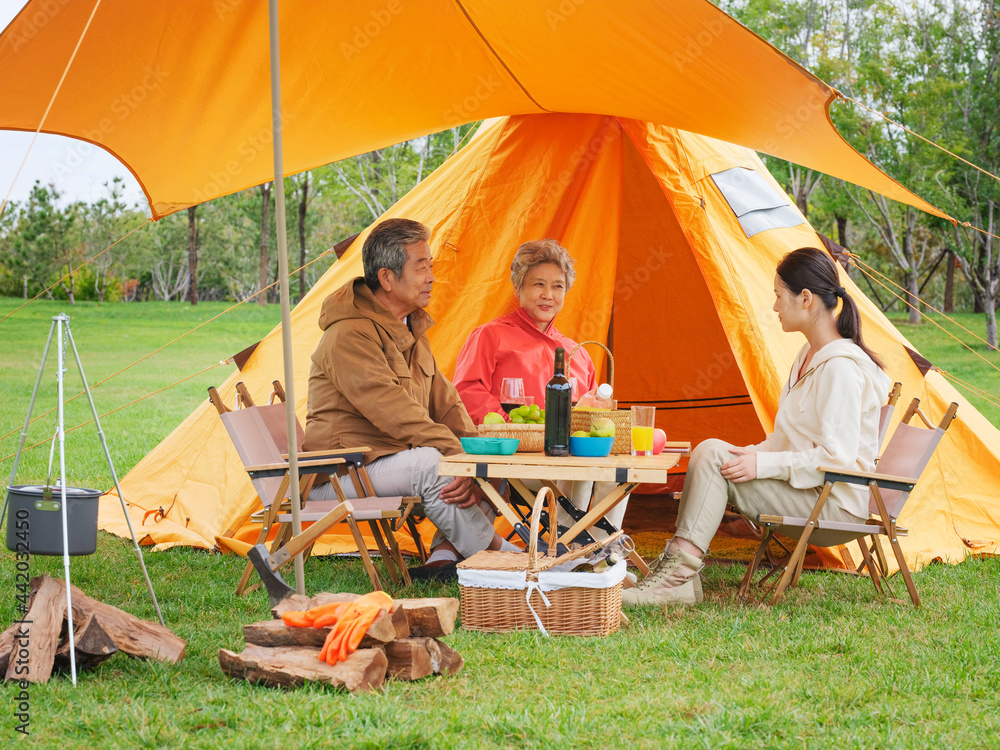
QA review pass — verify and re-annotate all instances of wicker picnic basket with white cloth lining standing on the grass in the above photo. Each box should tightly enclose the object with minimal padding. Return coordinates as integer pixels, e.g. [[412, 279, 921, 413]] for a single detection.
[[458, 487, 625, 635]]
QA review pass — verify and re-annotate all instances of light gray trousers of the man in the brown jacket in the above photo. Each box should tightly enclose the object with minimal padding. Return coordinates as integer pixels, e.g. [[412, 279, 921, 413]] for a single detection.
[[310, 448, 494, 557]]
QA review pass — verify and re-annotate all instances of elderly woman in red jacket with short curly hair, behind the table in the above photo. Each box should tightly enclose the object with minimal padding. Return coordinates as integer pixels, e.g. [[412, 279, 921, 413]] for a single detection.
[[454, 240, 628, 526]]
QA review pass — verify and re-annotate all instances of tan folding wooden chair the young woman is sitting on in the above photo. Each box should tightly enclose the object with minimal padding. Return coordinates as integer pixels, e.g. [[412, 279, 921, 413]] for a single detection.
[[739, 398, 958, 607]]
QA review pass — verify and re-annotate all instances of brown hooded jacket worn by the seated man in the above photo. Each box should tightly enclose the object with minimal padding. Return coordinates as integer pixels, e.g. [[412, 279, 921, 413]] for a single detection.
[[303, 278, 476, 461]]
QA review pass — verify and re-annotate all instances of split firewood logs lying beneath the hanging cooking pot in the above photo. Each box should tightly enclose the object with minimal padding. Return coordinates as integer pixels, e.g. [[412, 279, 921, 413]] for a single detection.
[[0, 575, 186, 683]]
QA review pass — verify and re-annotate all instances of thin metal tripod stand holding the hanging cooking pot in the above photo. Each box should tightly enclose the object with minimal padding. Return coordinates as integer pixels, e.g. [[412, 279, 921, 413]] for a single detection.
[[0, 313, 164, 685]]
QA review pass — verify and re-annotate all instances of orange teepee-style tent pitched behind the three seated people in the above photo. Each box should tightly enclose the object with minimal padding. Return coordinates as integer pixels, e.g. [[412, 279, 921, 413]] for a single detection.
[[101, 115, 1000, 567]]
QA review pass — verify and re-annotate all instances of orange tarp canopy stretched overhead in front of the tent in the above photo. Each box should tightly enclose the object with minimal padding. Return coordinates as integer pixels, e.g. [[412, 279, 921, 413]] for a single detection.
[[0, 0, 942, 218]]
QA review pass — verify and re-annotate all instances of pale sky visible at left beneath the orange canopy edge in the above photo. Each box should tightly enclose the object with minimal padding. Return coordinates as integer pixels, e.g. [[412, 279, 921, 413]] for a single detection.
[[0, 0, 148, 211]]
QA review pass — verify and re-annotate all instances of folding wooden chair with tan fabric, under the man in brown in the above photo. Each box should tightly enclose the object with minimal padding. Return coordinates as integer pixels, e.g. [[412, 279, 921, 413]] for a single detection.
[[208, 381, 419, 595]]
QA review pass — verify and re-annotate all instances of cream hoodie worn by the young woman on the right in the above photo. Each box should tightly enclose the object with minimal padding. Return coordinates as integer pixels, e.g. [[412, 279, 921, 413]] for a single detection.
[[755, 339, 892, 518]]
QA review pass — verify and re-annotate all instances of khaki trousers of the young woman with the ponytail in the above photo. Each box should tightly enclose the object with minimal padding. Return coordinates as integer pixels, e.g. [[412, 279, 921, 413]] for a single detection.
[[676, 438, 865, 552]]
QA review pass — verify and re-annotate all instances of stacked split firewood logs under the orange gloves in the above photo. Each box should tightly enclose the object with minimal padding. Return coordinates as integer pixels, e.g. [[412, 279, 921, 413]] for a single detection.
[[219, 593, 465, 692]]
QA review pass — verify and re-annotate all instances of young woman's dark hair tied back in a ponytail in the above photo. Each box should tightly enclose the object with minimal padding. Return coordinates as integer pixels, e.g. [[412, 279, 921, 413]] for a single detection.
[[778, 247, 885, 369]]
